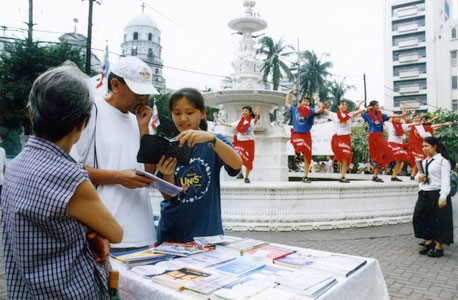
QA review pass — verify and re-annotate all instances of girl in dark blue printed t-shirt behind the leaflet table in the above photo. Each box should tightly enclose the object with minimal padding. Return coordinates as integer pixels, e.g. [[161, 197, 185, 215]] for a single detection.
[[157, 88, 242, 243]]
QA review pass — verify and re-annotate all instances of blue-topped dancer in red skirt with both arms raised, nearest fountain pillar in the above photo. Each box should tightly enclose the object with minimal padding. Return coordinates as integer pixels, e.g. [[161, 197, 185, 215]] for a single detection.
[[285, 89, 328, 183]]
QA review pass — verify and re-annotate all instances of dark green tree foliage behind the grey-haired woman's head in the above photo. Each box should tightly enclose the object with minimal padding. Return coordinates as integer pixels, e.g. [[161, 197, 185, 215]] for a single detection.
[[0, 40, 84, 154]]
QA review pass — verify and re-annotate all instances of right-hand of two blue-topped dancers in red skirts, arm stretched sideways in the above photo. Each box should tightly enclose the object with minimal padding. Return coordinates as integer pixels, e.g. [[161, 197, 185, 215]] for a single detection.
[[362, 100, 407, 182]]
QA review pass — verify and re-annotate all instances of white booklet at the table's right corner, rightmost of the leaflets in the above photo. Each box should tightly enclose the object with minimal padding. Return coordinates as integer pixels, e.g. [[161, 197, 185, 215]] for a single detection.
[[307, 254, 367, 277]]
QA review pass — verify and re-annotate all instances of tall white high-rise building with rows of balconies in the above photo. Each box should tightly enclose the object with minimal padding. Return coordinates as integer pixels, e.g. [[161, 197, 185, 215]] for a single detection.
[[384, 0, 458, 112]]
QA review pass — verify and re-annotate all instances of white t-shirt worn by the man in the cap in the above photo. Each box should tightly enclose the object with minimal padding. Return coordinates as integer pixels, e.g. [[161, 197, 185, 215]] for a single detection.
[[70, 99, 156, 248]]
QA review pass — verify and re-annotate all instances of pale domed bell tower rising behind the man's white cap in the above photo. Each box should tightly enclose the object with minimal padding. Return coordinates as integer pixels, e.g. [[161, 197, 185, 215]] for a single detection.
[[121, 13, 165, 92]]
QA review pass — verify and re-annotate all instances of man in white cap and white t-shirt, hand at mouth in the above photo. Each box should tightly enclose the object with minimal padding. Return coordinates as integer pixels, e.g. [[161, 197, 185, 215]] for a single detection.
[[70, 57, 157, 251]]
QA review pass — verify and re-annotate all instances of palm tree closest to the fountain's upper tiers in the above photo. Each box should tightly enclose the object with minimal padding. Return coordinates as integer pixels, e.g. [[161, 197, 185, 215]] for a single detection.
[[257, 36, 294, 91]]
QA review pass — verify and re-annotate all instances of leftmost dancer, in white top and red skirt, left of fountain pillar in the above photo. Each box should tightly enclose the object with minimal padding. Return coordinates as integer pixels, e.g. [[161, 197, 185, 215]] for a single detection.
[[219, 106, 261, 183]]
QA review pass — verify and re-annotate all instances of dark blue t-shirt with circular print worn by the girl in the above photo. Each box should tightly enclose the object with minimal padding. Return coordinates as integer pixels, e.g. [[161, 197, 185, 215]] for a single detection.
[[157, 134, 239, 243]]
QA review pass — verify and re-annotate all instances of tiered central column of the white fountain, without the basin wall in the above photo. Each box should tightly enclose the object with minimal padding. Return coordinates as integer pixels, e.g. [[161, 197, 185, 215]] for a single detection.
[[204, 0, 288, 181]]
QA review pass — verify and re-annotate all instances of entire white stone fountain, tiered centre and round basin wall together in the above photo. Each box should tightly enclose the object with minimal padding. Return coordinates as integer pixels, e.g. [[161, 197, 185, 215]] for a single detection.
[[151, 0, 432, 231]]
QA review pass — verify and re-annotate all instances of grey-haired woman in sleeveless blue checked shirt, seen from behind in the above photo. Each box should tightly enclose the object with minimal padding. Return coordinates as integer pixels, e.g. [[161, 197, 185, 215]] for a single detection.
[[1, 66, 123, 299]]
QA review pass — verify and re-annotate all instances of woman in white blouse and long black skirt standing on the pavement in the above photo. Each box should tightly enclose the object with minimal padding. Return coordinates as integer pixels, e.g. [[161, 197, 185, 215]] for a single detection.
[[413, 137, 455, 257]]
